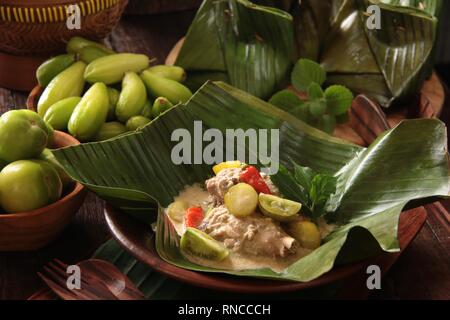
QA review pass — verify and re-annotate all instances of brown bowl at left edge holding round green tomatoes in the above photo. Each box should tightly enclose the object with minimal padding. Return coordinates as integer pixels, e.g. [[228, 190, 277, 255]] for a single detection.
[[0, 131, 86, 251]]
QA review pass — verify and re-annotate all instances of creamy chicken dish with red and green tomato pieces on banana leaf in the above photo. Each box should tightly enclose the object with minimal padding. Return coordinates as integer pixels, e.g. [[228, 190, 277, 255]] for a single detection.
[[165, 161, 333, 272]]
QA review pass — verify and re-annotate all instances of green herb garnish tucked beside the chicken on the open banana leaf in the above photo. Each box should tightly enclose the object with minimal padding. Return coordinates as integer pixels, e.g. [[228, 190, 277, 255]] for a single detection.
[[271, 162, 337, 219]]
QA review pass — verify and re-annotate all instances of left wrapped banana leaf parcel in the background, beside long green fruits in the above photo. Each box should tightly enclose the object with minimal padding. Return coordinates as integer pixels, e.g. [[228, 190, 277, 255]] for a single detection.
[[176, 0, 294, 98]]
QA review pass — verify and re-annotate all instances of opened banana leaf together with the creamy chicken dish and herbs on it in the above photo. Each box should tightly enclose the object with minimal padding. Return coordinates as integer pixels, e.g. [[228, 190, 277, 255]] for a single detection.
[[54, 81, 450, 281]]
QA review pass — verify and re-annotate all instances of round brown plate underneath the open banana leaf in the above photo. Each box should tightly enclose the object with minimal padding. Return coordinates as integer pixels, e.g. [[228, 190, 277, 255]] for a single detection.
[[105, 204, 426, 294]]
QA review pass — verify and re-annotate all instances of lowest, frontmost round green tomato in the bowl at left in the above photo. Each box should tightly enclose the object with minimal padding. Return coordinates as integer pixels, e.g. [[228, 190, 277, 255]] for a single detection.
[[0, 160, 62, 213]]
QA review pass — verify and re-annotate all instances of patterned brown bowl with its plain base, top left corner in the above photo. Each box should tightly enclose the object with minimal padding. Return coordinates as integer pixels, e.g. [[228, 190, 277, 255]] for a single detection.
[[0, 0, 128, 91]]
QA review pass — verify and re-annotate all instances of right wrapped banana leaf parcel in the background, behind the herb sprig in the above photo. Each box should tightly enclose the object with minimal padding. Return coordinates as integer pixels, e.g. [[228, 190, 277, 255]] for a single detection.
[[294, 0, 442, 107]]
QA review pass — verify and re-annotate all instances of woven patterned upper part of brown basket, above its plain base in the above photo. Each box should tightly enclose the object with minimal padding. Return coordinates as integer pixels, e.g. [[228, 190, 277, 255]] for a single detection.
[[0, 0, 128, 56]]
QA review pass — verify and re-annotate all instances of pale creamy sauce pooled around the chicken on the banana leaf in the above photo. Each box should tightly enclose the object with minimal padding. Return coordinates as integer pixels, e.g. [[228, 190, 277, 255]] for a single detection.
[[167, 184, 332, 272]]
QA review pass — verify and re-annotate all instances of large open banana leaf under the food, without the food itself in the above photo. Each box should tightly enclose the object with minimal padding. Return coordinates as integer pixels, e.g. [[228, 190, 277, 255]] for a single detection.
[[54, 82, 449, 281]]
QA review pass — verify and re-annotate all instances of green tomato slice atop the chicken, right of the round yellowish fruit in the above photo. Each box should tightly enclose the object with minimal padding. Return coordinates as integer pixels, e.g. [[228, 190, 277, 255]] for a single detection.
[[259, 193, 302, 222]]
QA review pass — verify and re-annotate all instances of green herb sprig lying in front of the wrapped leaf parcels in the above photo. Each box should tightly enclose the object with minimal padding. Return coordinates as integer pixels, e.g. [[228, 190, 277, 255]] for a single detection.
[[269, 59, 353, 134]]
